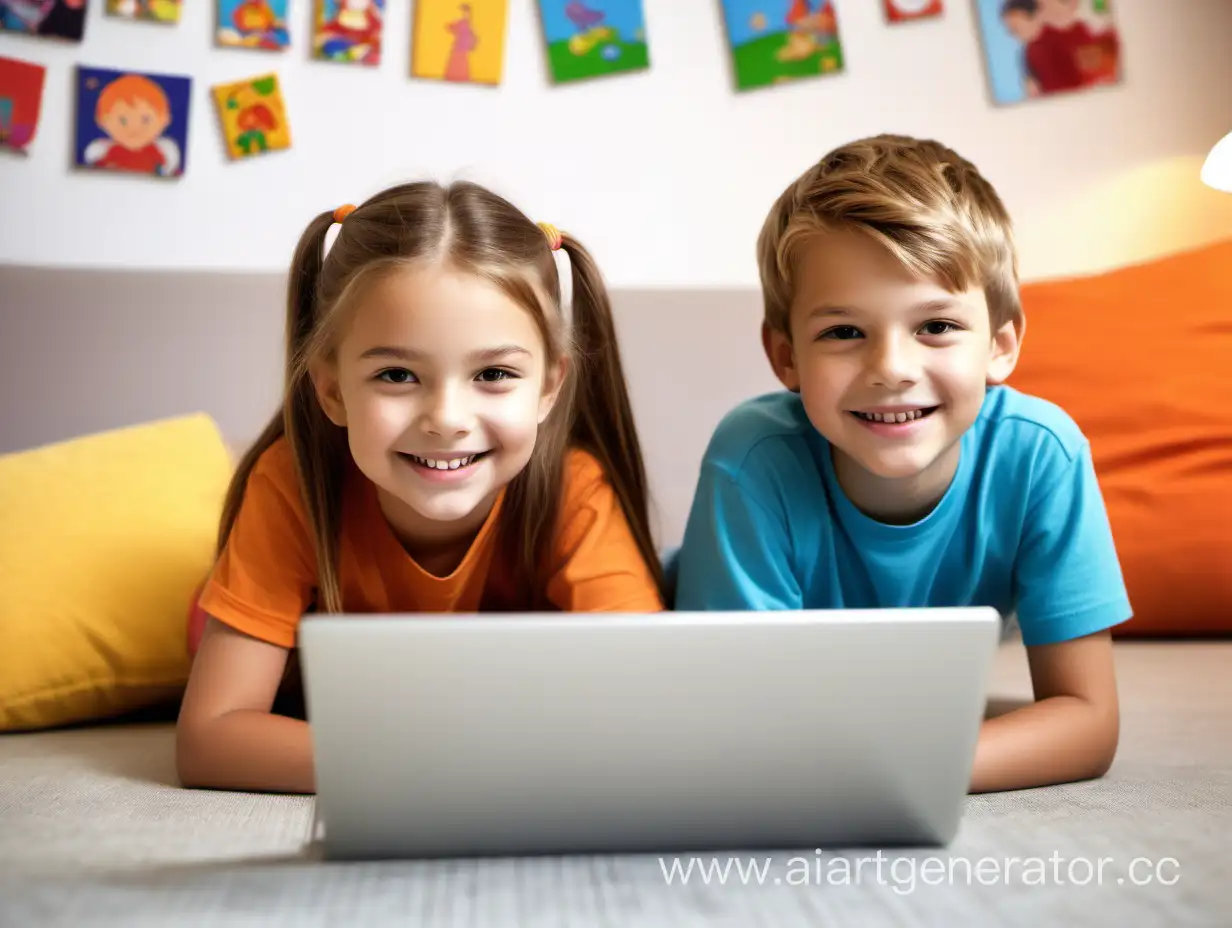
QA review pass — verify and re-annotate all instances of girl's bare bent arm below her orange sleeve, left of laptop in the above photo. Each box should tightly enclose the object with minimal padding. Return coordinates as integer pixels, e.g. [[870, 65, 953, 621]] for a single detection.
[[175, 617, 315, 792]]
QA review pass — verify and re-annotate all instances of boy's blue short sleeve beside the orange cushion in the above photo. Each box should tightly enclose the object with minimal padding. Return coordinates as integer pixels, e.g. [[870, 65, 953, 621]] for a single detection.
[[1015, 441, 1132, 646]]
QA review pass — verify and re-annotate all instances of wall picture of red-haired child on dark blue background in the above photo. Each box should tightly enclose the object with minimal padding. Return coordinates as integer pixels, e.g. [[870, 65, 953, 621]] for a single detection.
[[76, 67, 192, 177]]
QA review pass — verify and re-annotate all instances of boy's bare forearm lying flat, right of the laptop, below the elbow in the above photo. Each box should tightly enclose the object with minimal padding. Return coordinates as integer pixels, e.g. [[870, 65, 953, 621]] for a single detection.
[[971, 696, 1119, 792]]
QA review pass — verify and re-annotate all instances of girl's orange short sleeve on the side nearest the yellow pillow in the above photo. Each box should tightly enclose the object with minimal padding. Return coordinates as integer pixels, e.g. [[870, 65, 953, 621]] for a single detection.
[[200, 442, 317, 648]]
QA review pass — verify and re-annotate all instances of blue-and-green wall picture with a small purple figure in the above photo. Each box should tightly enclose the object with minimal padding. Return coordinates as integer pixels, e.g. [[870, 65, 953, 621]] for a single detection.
[[538, 0, 650, 84]]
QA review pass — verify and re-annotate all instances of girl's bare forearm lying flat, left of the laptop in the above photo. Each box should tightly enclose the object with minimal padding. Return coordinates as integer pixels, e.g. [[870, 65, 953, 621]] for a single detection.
[[176, 710, 317, 792]]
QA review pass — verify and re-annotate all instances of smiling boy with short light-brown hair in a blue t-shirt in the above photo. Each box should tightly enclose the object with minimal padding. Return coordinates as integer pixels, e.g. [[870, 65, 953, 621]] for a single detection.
[[675, 136, 1131, 792]]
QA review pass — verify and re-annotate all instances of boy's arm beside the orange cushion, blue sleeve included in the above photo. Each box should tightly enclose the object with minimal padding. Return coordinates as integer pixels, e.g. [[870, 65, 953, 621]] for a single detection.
[[971, 444, 1131, 792]]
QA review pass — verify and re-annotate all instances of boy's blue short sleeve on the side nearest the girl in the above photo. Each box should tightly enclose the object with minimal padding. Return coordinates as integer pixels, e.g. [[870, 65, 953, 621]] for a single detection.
[[675, 462, 803, 611]]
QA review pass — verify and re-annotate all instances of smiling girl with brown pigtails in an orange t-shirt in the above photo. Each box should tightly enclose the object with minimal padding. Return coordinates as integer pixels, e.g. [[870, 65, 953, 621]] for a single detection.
[[176, 184, 663, 792]]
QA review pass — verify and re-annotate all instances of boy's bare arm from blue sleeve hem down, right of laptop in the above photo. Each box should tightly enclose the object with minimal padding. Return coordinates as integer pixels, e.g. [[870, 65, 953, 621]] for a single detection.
[[971, 631, 1120, 792]]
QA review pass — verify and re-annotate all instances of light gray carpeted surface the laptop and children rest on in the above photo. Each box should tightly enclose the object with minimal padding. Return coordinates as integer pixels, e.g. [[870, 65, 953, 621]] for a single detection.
[[0, 642, 1232, 928]]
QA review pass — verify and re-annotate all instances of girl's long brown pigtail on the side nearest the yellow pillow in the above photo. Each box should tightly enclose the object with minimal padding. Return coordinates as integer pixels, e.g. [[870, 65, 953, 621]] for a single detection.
[[217, 212, 346, 613]]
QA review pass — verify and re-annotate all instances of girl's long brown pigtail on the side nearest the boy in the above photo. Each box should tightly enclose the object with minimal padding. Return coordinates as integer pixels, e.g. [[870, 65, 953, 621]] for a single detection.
[[561, 234, 663, 592]]
